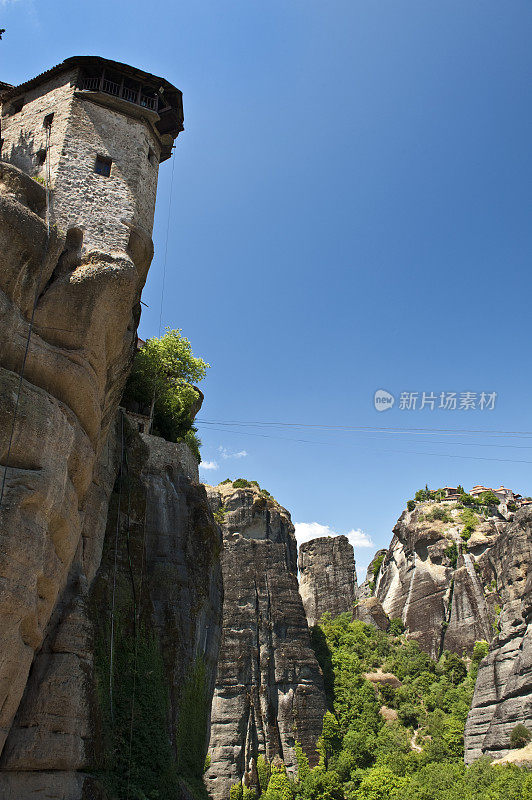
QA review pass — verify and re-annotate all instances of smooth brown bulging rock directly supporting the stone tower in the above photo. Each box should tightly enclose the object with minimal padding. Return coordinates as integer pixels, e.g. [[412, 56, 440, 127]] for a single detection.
[[0, 162, 151, 764]]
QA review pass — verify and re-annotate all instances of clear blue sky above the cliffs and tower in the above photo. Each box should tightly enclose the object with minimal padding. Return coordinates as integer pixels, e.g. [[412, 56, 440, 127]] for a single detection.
[[4, 0, 532, 567]]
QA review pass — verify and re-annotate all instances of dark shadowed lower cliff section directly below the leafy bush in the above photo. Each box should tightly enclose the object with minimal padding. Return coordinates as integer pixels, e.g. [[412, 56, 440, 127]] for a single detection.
[[0, 417, 222, 800]]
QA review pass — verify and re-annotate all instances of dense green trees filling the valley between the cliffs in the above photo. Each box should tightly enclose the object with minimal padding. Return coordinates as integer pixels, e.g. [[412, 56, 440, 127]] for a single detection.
[[234, 614, 532, 800]]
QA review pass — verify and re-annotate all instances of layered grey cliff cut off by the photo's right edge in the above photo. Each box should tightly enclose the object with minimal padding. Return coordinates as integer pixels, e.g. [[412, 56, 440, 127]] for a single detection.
[[465, 509, 532, 762]]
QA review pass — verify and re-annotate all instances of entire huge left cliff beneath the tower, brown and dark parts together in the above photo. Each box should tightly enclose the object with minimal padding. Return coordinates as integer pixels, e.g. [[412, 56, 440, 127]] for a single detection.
[[0, 162, 222, 800]]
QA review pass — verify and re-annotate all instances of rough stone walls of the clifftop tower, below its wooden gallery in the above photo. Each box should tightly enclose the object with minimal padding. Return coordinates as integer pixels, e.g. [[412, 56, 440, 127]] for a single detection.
[[2, 69, 160, 252]]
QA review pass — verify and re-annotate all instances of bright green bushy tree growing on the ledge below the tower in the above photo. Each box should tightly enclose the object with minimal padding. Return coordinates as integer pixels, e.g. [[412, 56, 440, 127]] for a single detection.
[[123, 329, 209, 458]]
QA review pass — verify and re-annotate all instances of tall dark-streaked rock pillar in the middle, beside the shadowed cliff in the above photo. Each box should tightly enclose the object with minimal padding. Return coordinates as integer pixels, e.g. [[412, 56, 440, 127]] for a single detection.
[[206, 483, 325, 800]]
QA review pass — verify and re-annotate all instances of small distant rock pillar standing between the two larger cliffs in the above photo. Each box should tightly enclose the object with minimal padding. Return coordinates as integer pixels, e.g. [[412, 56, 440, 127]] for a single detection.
[[299, 536, 357, 626]]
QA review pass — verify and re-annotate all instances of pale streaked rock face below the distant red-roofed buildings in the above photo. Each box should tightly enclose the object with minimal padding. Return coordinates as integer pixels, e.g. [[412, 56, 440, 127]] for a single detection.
[[375, 502, 494, 658]]
